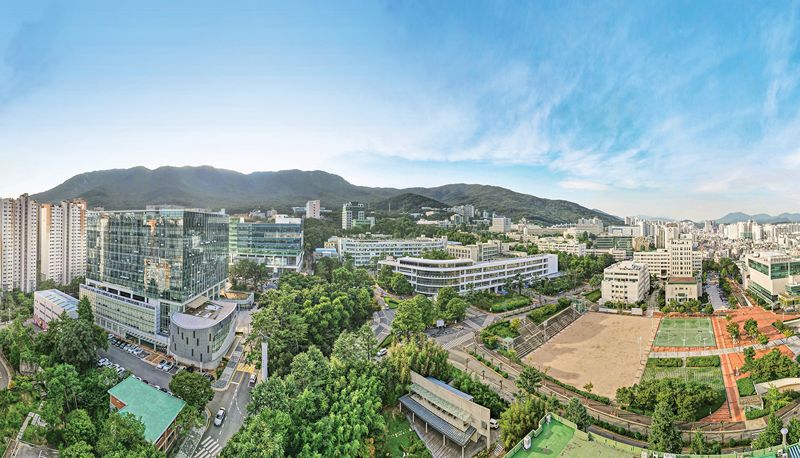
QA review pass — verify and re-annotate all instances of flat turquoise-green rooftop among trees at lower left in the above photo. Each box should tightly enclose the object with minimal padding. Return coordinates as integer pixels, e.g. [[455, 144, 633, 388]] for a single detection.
[[108, 376, 186, 443]]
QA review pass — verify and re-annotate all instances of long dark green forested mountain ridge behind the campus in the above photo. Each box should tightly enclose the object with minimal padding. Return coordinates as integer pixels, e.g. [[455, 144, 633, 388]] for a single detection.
[[32, 165, 621, 224]]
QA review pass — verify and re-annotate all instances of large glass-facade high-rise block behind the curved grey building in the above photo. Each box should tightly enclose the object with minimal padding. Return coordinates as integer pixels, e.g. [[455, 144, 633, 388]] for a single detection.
[[81, 208, 228, 347]]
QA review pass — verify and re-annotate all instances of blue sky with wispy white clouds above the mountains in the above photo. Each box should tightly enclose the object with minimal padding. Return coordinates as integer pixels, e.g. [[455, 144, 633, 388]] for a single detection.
[[0, 0, 800, 219]]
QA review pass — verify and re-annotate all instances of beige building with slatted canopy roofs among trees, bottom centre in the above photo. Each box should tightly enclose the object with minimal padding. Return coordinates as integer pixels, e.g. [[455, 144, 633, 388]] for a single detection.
[[400, 371, 491, 458]]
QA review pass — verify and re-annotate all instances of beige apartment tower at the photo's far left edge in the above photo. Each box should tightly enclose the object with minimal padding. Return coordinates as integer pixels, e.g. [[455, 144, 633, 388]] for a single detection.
[[0, 194, 39, 293]]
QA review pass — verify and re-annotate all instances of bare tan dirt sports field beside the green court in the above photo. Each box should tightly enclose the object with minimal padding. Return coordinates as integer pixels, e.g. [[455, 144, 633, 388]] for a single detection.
[[524, 312, 658, 398]]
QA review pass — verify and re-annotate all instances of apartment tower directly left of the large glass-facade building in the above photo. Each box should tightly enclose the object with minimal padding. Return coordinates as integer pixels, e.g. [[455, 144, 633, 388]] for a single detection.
[[39, 200, 87, 285]]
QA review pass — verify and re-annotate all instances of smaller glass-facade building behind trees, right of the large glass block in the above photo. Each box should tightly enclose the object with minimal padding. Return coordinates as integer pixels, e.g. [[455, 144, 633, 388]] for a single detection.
[[228, 218, 303, 274]]
